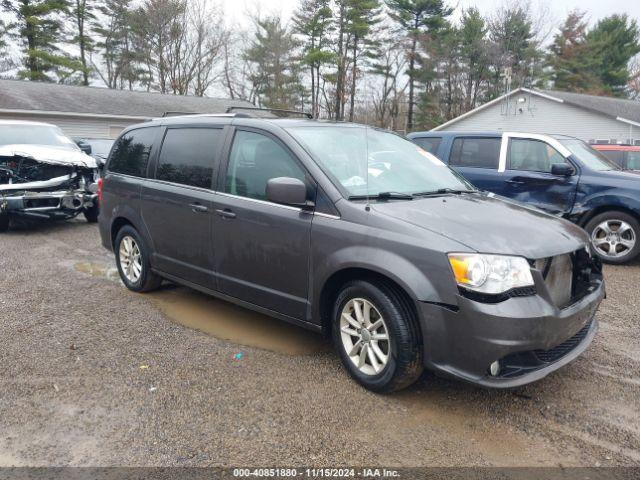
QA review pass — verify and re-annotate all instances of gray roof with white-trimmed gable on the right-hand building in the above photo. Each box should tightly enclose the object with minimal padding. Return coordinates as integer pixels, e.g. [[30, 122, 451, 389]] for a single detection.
[[433, 88, 640, 130]]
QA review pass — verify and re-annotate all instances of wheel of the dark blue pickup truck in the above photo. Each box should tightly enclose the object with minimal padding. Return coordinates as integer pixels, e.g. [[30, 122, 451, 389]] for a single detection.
[[585, 211, 640, 264]]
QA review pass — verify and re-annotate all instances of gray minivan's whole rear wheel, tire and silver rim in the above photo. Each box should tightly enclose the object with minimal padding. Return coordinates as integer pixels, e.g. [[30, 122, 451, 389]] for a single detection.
[[115, 225, 162, 293]]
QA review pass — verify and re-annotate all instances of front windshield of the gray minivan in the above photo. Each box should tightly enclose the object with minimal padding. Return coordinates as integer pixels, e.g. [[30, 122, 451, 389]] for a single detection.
[[287, 125, 473, 199]]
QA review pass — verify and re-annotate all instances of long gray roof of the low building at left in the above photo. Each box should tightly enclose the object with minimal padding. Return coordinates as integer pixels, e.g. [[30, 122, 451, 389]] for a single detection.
[[0, 80, 253, 119]]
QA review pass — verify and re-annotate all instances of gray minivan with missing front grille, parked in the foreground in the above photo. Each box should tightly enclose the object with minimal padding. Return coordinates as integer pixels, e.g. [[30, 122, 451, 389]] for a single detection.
[[99, 113, 604, 392]]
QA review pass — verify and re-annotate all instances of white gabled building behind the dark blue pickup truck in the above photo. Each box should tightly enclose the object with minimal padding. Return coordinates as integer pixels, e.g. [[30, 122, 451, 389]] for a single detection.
[[434, 88, 640, 145]]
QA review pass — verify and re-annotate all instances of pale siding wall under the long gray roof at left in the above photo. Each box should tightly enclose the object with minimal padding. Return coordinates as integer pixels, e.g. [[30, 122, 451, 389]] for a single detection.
[[0, 113, 144, 139]]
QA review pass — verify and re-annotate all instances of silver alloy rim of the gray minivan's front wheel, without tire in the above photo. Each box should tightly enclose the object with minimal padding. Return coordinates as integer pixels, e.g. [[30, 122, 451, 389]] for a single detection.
[[340, 298, 391, 375]]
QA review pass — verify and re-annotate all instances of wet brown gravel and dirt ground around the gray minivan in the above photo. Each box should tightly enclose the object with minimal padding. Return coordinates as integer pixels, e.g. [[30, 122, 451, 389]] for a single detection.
[[0, 220, 640, 466]]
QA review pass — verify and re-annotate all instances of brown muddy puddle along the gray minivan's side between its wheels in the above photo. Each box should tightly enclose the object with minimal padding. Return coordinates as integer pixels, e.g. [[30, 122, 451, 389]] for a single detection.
[[148, 286, 330, 355]]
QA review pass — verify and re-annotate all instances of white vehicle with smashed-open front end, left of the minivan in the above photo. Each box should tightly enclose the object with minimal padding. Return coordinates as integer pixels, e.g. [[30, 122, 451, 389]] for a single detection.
[[0, 120, 99, 232]]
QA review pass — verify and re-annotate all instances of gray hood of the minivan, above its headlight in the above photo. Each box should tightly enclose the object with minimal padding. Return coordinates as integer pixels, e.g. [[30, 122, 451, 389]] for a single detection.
[[372, 194, 589, 259]]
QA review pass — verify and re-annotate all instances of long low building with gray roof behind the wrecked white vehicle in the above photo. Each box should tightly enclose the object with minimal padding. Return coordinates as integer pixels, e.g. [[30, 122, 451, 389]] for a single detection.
[[0, 80, 253, 138]]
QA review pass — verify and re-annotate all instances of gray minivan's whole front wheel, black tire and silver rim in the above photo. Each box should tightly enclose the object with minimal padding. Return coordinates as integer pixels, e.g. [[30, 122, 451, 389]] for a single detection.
[[332, 280, 424, 393]]
